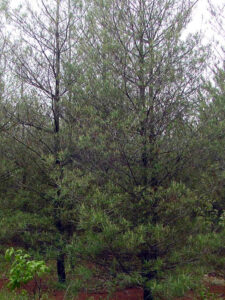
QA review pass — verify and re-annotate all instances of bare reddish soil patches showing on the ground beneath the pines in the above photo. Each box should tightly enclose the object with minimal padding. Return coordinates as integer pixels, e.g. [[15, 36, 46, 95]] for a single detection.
[[0, 279, 225, 300]]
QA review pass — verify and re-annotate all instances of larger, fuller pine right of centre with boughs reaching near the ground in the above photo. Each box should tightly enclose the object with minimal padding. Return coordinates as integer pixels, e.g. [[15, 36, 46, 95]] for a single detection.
[[68, 0, 216, 299]]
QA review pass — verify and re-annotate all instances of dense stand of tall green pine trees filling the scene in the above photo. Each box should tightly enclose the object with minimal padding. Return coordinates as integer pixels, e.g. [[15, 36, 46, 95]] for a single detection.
[[0, 0, 225, 299]]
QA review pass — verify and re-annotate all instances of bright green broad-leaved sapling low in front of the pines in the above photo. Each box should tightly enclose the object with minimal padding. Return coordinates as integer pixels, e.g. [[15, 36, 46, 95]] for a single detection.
[[5, 248, 49, 290]]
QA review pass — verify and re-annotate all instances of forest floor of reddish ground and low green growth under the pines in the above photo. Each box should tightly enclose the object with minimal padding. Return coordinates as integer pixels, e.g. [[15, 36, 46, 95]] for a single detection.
[[0, 274, 225, 300]]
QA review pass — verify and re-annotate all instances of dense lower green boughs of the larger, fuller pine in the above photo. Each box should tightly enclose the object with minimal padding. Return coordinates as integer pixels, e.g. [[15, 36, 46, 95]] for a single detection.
[[71, 182, 220, 299]]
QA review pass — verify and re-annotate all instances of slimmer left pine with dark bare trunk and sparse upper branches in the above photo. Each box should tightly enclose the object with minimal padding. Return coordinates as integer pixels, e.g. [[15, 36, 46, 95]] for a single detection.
[[1, 0, 82, 282]]
